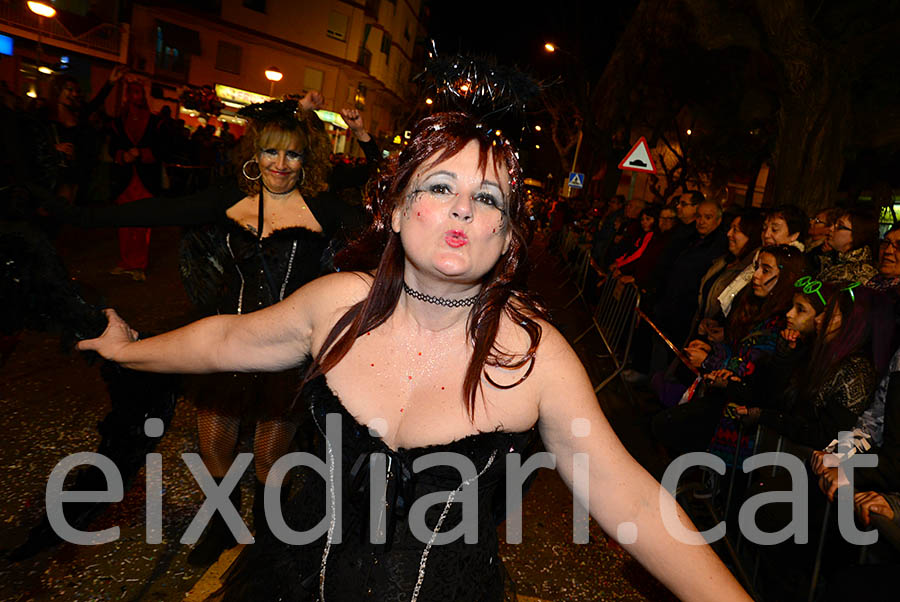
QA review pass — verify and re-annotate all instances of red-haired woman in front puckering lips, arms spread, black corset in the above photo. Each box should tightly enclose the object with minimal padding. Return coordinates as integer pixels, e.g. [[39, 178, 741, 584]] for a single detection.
[[79, 113, 749, 602]]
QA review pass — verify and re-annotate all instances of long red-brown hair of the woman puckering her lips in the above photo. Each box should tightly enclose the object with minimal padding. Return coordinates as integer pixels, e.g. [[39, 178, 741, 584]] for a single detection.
[[304, 113, 547, 419]]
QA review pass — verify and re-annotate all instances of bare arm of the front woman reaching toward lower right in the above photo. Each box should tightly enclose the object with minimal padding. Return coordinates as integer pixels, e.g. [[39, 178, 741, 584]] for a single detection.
[[536, 327, 750, 602]]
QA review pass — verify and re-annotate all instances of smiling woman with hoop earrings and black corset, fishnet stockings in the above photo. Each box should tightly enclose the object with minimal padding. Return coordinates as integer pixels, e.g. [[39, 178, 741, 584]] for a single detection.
[[46, 95, 377, 565]]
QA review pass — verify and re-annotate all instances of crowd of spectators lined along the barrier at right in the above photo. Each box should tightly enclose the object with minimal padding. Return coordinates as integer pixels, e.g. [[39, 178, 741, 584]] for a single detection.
[[549, 192, 900, 600]]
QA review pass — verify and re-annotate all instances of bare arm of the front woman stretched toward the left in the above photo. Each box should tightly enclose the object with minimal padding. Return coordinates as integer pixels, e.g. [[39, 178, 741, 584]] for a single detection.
[[78, 273, 358, 374]]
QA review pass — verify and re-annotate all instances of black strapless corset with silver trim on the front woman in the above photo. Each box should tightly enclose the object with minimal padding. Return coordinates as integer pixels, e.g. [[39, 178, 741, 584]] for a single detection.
[[216, 377, 534, 602]]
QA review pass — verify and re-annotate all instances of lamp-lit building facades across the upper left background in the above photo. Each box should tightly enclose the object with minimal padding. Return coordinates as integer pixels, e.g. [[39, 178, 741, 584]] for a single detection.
[[0, 0, 427, 152]]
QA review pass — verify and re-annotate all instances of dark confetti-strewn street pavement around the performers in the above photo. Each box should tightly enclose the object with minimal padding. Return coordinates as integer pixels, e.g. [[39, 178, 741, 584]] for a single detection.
[[0, 223, 674, 602]]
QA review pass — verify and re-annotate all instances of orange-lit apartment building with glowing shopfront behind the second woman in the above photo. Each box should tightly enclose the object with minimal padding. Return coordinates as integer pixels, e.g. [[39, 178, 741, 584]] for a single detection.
[[129, 0, 425, 152]]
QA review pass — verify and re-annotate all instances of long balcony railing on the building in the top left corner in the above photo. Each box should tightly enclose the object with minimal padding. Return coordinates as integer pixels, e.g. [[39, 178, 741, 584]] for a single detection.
[[0, 2, 128, 62]]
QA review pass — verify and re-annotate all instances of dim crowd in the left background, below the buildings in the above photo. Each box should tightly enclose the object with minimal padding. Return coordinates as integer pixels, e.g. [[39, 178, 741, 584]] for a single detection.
[[0, 66, 368, 280]]
